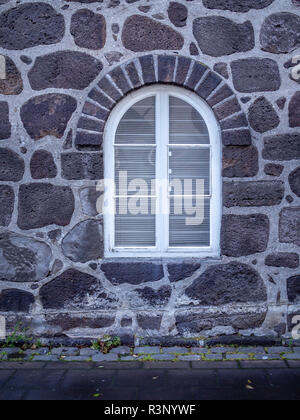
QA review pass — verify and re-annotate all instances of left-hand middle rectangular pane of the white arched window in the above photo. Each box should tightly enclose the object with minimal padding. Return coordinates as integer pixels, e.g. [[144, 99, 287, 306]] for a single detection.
[[115, 146, 156, 195]]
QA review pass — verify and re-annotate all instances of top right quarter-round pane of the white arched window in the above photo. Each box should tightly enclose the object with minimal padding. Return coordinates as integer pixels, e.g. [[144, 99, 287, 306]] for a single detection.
[[170, 96, 210, 144]]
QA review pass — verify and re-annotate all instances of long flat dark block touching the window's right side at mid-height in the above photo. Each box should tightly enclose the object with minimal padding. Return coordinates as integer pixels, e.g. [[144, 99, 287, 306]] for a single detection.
[[223, 181, 284, 207]]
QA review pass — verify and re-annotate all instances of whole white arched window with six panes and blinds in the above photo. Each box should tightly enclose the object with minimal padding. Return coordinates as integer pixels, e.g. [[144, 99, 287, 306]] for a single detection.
[[104, 85, 221, 258]]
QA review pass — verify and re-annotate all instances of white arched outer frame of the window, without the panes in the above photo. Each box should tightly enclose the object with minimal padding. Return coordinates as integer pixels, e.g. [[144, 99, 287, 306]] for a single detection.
[[103, 84, 222, 258]]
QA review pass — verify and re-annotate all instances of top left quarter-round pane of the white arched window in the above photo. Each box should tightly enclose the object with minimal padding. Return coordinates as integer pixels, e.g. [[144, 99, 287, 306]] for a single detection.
[[115, 96, 156, 144]]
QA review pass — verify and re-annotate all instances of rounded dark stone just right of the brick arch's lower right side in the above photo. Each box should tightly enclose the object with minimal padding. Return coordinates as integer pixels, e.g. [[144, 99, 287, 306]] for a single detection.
[[248, 96, 280, 133]]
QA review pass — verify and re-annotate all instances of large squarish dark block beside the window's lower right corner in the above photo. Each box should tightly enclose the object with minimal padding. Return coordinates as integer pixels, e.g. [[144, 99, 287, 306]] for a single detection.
[[221, 214, 270, 257]]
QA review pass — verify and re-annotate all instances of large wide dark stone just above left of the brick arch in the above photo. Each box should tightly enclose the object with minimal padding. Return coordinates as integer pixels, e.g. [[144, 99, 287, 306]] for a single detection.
[[28, 51, 103, 90]]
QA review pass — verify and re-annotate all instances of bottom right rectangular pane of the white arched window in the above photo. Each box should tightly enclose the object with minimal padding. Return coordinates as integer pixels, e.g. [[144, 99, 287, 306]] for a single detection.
[[169, 197, 210, 248]]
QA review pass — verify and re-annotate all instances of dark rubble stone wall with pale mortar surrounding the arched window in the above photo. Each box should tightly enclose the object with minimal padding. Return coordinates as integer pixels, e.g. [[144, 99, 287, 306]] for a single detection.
[[0, 0, 300, 337]]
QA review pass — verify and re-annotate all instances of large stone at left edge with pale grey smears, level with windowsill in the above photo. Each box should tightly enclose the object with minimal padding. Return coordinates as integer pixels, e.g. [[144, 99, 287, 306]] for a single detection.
[[0, 232, 52, 283]]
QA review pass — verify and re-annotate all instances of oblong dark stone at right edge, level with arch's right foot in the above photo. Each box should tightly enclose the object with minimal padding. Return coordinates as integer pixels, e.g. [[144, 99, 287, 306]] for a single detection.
[[262, 133, 300, 161]]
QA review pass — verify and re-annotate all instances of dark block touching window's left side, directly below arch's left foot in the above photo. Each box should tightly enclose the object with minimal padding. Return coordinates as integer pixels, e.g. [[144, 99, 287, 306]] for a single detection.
[[61, 152, 103, 180]]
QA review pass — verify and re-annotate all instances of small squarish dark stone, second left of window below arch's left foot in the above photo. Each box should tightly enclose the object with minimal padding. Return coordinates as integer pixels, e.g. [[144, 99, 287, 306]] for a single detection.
[[30, 150, 57, 179]]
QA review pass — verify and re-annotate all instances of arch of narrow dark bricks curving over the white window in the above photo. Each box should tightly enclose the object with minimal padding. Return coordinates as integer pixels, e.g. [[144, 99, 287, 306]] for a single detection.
[[75, 54, 252, 150]]
